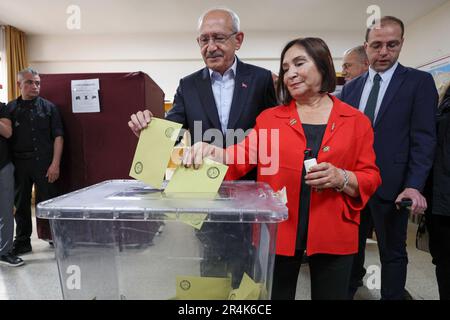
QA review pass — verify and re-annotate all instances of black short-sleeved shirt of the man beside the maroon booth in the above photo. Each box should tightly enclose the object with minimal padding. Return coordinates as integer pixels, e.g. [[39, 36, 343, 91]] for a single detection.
[[7, 97, 64, 164]]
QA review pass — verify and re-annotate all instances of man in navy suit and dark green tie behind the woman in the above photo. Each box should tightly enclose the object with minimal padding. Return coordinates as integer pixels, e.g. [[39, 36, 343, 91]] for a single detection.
[[341, 17, 438, 299]]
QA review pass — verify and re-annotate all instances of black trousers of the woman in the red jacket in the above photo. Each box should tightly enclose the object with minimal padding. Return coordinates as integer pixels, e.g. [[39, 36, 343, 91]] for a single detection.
[[272, 251, 353, 300]]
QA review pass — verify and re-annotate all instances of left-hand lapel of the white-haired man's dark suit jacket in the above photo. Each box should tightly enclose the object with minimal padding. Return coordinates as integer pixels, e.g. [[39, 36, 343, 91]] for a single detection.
[[195, 68, 222, 131]]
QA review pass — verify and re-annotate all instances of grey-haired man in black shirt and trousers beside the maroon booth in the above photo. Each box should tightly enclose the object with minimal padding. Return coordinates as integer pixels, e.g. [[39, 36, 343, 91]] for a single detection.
[[7, 68, 63, 255]]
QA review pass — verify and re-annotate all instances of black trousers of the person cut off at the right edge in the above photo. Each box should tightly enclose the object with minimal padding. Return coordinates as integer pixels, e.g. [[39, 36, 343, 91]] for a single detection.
[[426, 214, 450, 300]]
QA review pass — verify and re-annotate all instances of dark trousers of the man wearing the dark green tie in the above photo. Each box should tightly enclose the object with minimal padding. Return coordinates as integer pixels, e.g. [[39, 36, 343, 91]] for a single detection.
[[349, 195, 408, 300]]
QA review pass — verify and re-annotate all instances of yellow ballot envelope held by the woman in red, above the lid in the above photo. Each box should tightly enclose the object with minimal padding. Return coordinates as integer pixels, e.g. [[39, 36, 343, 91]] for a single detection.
[[164, 158, 228, 196]]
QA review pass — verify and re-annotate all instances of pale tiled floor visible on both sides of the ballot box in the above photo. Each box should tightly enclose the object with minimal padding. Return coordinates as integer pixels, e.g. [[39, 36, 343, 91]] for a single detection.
[[0, 219, 438, 300]]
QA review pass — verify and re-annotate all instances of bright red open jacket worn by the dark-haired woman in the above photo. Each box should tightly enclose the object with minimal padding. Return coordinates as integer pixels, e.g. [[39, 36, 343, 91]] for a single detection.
[[226, 96, 381, 256]]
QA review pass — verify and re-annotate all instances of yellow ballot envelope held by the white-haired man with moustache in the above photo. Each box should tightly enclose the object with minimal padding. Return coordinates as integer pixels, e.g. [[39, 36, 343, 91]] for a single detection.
[[130, 118, 182, 188]]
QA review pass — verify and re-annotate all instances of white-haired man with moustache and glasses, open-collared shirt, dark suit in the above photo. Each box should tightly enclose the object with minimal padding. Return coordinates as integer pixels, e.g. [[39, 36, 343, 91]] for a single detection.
[[128, 9, 277, 146]]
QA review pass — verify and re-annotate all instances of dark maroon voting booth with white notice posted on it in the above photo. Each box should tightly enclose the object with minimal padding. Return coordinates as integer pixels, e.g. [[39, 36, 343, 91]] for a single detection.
[[36, 72, 164, 244]]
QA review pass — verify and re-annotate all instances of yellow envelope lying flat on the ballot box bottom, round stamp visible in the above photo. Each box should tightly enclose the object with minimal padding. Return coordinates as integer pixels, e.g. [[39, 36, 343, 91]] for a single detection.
[[176, 276, 232, 300]]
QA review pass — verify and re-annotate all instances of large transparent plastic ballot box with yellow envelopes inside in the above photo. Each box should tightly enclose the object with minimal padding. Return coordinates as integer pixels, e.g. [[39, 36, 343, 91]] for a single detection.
[[37, 180, 288, 300]]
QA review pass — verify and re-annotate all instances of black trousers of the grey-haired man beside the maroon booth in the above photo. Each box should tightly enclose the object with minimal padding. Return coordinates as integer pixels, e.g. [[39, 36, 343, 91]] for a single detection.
[[14, 159, 56, 243]]
